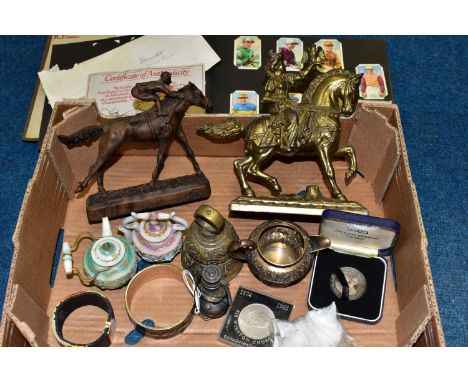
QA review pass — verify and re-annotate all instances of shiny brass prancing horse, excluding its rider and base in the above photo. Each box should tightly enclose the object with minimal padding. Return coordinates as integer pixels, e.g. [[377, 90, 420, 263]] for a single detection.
[[197, 69, 362, 202]]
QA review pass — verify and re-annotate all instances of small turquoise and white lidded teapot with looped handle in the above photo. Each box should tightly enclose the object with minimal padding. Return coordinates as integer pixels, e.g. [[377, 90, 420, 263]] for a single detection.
[[62, 217, 137, 289]]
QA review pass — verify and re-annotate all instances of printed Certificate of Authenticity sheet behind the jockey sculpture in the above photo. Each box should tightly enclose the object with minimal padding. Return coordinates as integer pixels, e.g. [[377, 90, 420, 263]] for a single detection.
[[86, 65, 205, 117]]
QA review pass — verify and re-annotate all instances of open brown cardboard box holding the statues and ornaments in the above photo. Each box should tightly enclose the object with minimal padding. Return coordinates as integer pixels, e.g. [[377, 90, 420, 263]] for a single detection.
[[0, 100, 444, 346]]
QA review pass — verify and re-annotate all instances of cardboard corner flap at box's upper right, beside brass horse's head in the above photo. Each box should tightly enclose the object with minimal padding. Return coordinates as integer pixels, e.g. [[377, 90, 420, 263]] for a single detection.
[[349, 103, 401, 203]]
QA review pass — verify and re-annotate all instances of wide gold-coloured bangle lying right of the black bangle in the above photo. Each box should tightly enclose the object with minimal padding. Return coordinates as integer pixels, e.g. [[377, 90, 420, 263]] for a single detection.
[[125, 264, 195, 338]]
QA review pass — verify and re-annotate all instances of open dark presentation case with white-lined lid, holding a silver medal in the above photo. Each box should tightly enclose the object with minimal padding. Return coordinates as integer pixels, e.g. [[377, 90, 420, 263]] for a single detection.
[[308, 210, 400, 324]]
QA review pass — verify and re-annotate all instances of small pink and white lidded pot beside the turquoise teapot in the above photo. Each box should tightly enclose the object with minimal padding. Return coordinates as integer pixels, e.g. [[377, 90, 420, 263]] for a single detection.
[[119, 212, 188, 263]]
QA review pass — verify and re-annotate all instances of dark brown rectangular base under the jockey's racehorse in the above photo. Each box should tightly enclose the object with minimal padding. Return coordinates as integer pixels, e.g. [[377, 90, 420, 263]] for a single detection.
[[86, 174, 211, 223]]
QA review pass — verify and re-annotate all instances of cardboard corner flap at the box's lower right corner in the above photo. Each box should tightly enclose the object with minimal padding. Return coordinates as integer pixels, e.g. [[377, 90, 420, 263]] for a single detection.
[[396, 285, 432, 346]]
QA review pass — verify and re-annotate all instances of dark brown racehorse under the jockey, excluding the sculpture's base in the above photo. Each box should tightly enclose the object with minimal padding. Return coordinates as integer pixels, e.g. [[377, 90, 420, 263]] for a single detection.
[[58, 82, 211, 193]]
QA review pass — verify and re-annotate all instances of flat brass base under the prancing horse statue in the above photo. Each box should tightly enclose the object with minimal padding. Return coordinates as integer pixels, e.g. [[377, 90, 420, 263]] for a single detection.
[[229, 185, 369, 215]]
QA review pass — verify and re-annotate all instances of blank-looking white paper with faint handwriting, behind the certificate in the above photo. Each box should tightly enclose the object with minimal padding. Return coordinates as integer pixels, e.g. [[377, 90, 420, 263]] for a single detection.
[[39, 36, 220, 107]]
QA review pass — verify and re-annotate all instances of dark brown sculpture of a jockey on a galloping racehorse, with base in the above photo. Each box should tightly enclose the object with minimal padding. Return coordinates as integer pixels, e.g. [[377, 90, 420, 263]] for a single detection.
[[58, 81, 211, 222]]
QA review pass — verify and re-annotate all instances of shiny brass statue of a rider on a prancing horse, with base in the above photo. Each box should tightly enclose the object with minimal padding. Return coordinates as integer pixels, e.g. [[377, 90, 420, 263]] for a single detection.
[[197, 46, 365, 215]]
